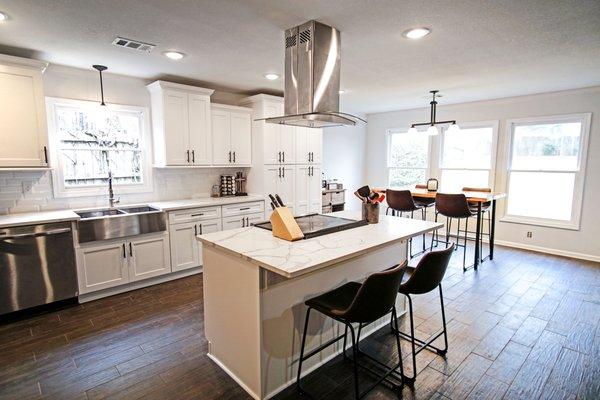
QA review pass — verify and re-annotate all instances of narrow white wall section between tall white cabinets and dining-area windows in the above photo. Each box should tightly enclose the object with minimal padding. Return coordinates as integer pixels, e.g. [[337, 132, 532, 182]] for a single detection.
[[323, 123, 367, 210]]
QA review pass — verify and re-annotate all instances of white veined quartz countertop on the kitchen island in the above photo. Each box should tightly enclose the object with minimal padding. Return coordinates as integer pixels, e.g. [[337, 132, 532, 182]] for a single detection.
[[198, 211, 443, 278]]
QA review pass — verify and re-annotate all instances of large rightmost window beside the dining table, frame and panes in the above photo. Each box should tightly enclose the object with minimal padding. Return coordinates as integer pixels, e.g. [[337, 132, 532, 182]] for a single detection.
[[504, 114, 590, 229]]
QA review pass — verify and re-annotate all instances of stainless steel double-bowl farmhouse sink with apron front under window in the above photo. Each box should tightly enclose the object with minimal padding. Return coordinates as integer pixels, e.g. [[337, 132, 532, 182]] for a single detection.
[[77, 206, 167, 243]]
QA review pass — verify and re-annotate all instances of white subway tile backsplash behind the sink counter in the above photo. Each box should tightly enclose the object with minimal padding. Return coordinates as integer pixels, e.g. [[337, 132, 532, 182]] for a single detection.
[[0, 168, 248, 214]]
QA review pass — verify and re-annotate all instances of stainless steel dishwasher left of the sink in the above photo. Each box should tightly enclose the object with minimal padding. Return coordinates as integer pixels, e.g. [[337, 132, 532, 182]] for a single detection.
[[0, 222, 78, 314]]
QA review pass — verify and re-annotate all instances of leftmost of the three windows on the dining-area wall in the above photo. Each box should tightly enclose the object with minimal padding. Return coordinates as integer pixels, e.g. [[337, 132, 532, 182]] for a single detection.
[[388, 130, 429, 187]]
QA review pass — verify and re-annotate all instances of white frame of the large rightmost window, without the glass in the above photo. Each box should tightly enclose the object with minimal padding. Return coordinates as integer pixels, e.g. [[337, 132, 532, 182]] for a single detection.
[[500, 113, 592, 230]]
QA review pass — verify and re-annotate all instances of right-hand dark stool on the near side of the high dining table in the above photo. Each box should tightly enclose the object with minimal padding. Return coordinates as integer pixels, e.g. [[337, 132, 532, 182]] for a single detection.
[[431, 193, 479, 271]]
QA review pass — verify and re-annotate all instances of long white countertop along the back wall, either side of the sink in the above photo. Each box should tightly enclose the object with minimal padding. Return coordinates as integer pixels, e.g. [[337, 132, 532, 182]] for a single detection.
[[0, 195, 264, 228]]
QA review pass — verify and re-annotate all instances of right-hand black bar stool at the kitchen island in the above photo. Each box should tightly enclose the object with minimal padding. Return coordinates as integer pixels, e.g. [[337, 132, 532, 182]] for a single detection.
[[391, 244, 454, 385]]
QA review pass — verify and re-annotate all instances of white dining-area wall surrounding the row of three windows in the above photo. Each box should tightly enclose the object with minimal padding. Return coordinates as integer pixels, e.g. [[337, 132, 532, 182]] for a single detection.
[[366, 87, 600, 261]]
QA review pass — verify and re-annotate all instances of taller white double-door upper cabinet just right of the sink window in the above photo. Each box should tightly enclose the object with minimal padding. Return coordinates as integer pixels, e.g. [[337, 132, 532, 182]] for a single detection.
[[147, 81, 213, 166]]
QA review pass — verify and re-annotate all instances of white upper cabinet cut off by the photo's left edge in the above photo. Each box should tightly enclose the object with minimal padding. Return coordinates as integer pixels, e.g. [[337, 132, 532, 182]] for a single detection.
[[0, 55, 48, 168]]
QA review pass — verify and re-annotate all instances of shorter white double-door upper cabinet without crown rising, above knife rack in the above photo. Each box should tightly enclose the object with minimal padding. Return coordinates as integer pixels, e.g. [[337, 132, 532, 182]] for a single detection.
[[211, 104, 252, 167]]
